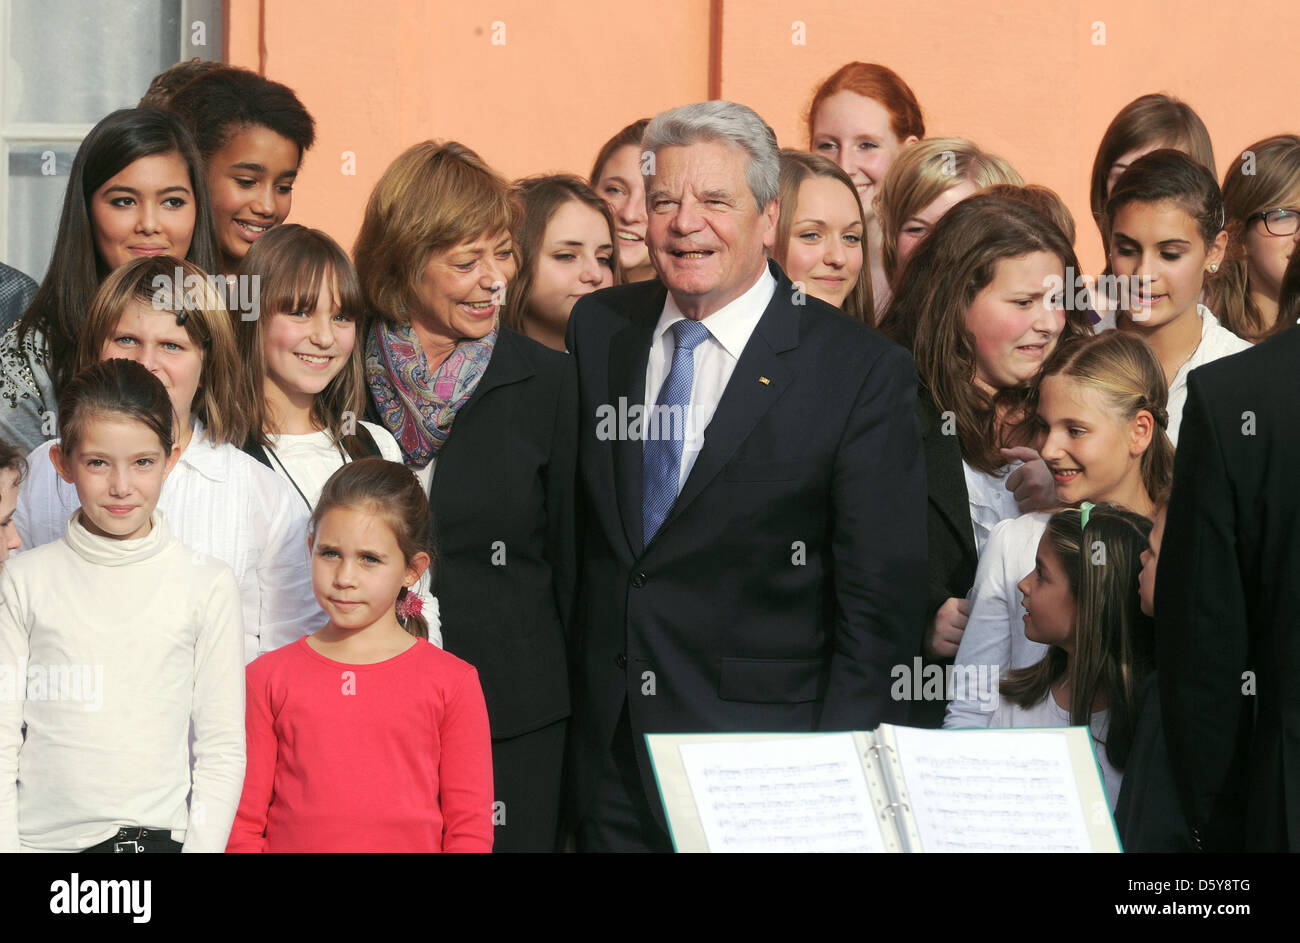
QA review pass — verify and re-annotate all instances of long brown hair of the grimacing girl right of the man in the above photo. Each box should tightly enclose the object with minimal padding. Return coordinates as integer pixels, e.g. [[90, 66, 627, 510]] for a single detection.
[[880, 193, 1092, 473]]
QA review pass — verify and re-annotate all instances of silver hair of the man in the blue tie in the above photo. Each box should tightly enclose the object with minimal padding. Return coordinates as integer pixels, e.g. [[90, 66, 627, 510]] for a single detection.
[[641, 100, 781, 212]]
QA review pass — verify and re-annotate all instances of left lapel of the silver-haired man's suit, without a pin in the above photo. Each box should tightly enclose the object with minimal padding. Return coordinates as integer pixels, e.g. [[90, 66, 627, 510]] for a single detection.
[[610, 286, 667, 557]]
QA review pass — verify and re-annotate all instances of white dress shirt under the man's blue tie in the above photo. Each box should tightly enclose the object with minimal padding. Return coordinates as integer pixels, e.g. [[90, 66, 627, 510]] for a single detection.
[[645, 265, 776, 492]]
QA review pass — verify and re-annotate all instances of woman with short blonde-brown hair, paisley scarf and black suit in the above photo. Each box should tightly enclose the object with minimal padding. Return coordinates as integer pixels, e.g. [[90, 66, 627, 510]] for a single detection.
[[354, 140, 579, 852]]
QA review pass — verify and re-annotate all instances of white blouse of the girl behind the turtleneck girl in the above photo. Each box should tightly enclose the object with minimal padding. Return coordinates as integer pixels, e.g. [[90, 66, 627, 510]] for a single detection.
[[13, 421, 328, 661]]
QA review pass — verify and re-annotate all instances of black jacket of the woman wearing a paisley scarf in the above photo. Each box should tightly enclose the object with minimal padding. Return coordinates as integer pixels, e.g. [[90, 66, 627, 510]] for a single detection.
[[371, 328, 577, 739]]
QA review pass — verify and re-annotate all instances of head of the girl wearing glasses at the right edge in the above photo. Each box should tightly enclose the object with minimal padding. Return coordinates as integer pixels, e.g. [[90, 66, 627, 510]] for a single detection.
[[1209, 134, 1300, 341]]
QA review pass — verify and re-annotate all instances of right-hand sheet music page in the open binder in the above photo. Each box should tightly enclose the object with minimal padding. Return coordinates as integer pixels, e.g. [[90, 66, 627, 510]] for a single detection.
[[894, 727, 1092, 852]]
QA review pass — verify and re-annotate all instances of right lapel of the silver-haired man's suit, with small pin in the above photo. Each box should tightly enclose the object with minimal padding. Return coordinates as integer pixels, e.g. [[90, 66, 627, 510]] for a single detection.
[[659, 263, 800, 533]]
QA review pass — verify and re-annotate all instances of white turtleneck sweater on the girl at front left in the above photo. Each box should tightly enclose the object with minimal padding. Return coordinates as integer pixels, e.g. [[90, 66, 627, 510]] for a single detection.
[[0, 510, 244, 852]]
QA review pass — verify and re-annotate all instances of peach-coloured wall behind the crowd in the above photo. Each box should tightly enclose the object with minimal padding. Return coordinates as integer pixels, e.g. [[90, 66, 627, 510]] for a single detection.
[[228, 0, 1300, 269]]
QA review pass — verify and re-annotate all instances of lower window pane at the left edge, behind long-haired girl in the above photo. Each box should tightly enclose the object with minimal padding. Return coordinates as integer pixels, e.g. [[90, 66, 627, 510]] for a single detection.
[[5, 144, 77, 281]]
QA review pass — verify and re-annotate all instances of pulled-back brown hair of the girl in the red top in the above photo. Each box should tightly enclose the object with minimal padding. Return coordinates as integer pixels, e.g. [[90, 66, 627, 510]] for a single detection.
[[310, 455, 434, 639]]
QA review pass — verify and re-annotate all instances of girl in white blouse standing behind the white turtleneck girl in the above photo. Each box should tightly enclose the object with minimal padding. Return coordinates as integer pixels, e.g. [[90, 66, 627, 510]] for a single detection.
[[17, 255, 324, 661]]
